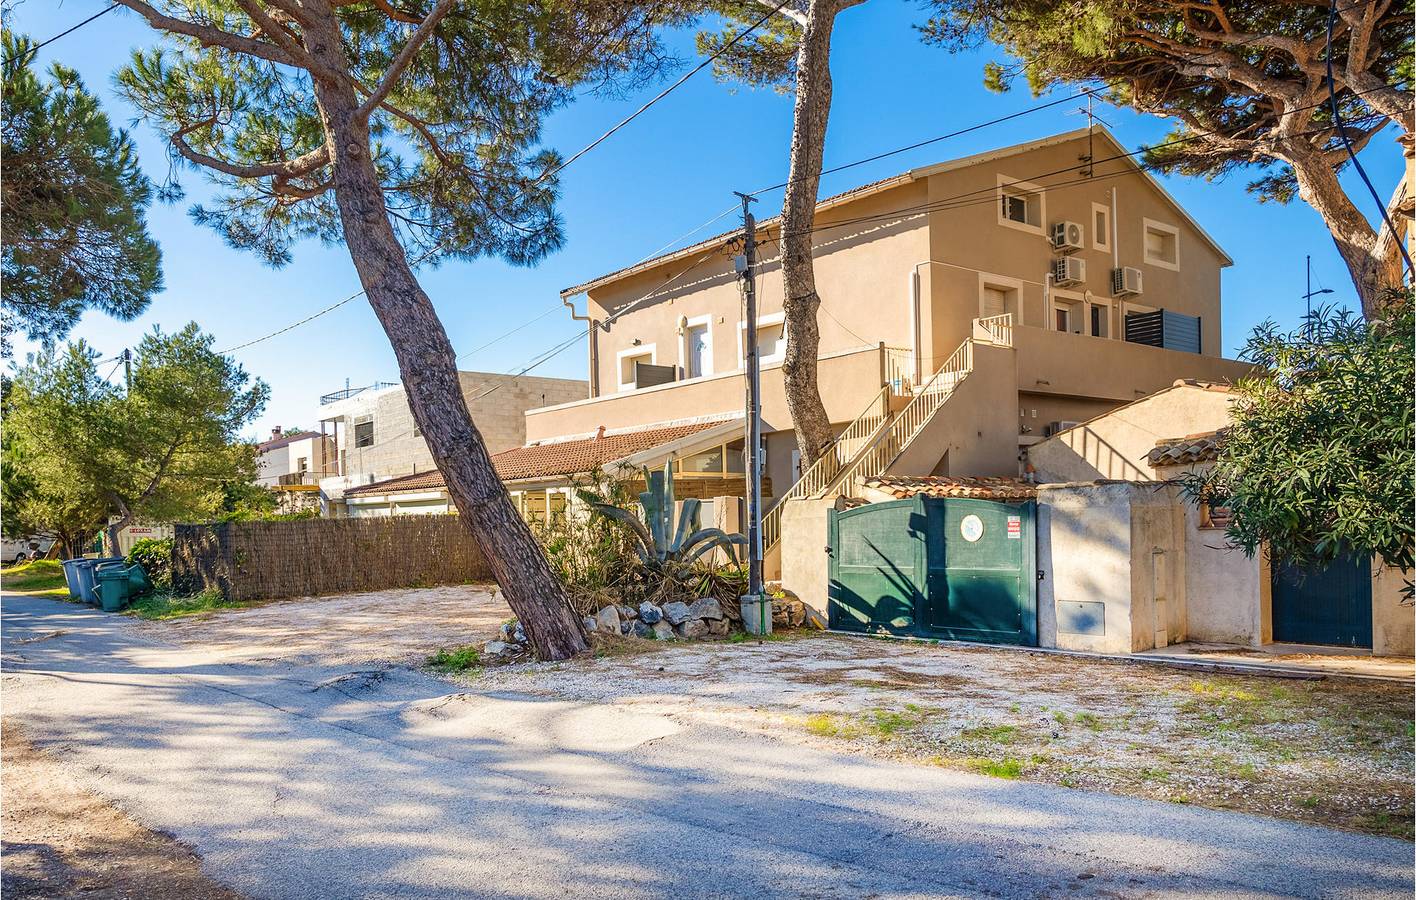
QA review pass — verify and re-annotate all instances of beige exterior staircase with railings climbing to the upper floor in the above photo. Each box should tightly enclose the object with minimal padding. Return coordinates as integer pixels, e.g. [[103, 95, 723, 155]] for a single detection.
[[762, 316, 1012, 572]]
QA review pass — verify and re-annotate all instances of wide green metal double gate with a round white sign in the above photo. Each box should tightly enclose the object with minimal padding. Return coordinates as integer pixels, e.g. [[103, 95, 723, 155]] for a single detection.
[[828, 497, 1038, 645]]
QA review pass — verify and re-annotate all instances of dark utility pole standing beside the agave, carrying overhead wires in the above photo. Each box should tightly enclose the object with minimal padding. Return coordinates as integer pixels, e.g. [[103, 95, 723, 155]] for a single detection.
[[733, 191, 772, 634]]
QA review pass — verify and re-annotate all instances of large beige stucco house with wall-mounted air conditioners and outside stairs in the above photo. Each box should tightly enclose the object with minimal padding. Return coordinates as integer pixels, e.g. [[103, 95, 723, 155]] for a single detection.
[[513, 127, 1245, 573]]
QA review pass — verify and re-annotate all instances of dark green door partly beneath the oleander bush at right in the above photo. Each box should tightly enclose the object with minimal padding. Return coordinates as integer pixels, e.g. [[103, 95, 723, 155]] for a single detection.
[[1273, 556, 1372, 647]]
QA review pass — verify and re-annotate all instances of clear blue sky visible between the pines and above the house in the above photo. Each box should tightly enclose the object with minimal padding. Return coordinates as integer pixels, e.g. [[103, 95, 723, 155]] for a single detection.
[[8, 0, 1402, 433]]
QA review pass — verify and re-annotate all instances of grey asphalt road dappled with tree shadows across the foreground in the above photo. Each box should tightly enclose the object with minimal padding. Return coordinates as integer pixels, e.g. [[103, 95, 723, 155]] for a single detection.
[[0, 596, 1413, 900]]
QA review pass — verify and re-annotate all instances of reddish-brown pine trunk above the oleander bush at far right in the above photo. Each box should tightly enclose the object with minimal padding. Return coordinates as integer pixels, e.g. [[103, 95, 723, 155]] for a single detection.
[[1283, 146, 1402, 318]]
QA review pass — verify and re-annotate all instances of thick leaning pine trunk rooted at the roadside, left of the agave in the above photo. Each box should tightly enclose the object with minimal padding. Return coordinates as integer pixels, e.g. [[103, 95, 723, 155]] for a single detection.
[[304, 3, 588, 659]]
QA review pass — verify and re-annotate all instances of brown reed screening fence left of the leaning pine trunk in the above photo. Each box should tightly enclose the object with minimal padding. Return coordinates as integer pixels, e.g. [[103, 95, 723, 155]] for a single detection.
[[173, 515, 491, 600]]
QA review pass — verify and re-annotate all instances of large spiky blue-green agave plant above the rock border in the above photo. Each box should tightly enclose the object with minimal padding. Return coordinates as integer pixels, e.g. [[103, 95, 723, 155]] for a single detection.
[[579, 460, 748, 569]]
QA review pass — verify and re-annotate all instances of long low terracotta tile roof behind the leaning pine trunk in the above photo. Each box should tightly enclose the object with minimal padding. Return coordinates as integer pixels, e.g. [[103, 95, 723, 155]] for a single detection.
[[344, 422, 722, 497]]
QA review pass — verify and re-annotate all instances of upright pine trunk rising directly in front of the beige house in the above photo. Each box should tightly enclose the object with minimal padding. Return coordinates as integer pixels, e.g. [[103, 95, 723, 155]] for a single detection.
[[782, 0, 858, 470]]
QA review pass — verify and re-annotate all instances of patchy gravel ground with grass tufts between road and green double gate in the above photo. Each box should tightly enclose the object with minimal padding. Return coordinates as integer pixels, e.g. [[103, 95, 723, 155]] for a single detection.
[[464, 635, 1413, 839]]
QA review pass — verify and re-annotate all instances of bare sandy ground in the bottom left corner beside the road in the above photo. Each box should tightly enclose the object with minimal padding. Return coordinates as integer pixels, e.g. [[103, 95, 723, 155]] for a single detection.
[[0, 722, 241, 900]]
